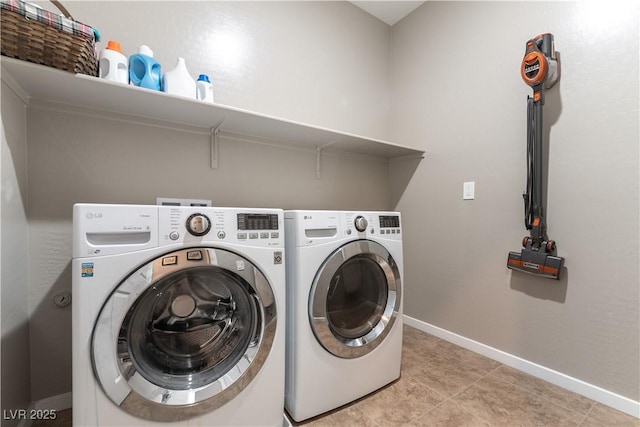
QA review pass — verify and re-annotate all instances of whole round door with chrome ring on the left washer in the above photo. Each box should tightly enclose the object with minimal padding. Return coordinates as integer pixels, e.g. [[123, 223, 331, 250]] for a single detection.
[[92, 248, 276, 421]]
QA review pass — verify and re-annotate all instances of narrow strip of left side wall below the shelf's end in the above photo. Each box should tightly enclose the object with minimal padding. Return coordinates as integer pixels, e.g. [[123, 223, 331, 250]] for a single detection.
[[0, 82, 31, 426]]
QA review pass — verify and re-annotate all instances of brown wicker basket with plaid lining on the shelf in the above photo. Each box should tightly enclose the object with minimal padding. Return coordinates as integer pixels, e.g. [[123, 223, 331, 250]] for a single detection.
[[0, 0, 98, 76]]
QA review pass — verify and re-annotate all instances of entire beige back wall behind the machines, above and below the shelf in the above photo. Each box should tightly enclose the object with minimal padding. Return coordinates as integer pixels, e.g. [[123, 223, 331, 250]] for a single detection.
[[21, 2, 391, 400]]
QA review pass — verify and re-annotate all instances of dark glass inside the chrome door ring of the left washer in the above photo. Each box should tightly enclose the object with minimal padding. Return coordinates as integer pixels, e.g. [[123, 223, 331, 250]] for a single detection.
[[118, 266, 260, 390]]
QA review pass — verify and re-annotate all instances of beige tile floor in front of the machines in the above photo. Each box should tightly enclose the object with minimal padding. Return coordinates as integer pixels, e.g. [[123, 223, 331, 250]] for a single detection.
[[33, 325, 640, 427]]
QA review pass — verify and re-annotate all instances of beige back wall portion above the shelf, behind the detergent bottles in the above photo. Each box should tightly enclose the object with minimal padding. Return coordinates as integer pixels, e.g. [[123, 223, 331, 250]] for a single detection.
[[61, 1, 391, 139]]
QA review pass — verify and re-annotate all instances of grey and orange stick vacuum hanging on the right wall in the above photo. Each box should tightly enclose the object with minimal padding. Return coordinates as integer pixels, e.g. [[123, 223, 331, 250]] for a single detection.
[[507, 34, 564, 279]]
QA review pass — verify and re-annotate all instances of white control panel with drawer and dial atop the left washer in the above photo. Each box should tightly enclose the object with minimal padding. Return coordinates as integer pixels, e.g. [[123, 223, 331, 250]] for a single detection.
[[73, 203, 284, 258]]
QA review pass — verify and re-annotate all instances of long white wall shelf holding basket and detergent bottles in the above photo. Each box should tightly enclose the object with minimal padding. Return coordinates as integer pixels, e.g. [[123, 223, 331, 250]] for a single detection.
[[1, 57, 424, 159]]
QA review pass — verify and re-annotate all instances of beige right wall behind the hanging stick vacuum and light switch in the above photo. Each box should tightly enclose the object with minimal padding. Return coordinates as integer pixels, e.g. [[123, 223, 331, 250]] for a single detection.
[[390, 2, 640, 401]]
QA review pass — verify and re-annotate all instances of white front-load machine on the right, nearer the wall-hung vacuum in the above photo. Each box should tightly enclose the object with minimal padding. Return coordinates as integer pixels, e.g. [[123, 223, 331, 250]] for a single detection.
[[284, 211, 402, 421]]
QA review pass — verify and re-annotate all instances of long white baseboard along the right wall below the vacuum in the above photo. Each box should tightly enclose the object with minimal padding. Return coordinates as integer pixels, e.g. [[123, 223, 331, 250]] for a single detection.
[[404, 315, 640, 418]]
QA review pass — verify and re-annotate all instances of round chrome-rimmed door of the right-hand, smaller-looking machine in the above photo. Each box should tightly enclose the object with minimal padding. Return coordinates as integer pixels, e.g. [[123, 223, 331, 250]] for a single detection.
[[309, 240, 400, 358]]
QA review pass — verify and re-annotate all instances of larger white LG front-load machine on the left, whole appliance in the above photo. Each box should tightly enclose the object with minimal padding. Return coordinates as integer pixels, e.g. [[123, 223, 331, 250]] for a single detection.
[[72, 204, 286, 426]]
